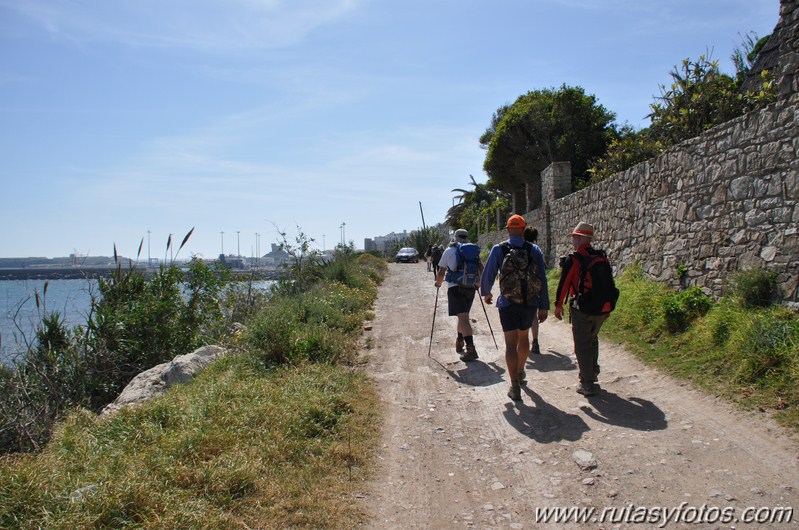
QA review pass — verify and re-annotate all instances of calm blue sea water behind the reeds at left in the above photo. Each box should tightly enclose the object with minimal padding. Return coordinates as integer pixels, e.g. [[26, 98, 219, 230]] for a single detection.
[[0, 279, 273, 364]]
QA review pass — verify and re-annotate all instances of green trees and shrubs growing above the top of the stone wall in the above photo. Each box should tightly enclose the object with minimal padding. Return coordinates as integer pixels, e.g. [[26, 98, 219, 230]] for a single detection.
[[454, 33, 777, 234]]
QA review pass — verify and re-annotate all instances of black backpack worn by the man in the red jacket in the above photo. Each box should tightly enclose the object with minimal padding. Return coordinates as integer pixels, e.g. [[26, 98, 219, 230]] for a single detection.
[[572, 249, 619, 315]]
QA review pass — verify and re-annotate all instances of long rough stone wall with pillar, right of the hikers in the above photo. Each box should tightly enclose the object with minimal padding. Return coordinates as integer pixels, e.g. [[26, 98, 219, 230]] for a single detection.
[[480, 0, 799, 302]]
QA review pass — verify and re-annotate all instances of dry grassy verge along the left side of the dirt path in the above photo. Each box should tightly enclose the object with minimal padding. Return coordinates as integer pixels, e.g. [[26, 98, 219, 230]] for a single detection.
[[0, 235, 386, 529]]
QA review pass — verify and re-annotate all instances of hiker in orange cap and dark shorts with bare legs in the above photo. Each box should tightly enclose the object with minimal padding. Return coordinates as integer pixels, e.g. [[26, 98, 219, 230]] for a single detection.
[[480, 215, 549, 401]]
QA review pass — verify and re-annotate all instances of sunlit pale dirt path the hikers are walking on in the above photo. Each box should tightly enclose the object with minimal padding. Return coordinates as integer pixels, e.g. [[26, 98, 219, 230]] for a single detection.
[[364, 263, 799, 529]]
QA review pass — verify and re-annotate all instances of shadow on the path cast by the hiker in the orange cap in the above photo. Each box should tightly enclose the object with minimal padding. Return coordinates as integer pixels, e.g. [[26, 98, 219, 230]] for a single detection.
[[502, 387, 590, 444]]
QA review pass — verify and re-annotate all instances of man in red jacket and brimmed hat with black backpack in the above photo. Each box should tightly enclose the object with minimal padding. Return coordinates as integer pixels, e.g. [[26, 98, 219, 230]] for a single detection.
[[555, 221, 619, 396]]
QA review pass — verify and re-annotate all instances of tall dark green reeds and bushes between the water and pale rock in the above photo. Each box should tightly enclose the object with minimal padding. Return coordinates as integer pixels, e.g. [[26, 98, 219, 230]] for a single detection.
[[0, 253, 231, 452]]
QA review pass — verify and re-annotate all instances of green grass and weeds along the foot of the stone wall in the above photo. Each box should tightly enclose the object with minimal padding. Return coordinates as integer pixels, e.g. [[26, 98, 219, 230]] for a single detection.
[[549, 265, 799, 432]]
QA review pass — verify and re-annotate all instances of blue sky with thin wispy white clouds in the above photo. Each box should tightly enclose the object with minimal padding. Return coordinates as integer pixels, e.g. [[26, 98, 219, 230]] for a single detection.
[[0, 0, 779, 258]]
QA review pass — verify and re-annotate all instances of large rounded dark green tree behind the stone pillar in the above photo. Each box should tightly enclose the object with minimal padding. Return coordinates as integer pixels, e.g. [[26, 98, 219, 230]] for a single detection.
[[481, 85, 615, 204]]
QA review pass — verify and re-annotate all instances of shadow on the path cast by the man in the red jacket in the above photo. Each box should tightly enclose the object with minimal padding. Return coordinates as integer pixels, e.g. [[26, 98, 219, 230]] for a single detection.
[[580, 390, 669, 431]]
